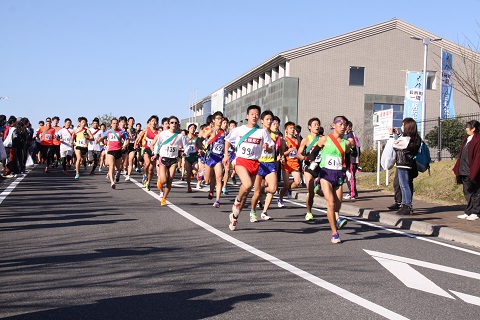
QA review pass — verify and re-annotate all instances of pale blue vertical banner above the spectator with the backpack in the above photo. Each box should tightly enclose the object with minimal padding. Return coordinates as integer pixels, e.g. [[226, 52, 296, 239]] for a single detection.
[[403, 71, 424, 130]]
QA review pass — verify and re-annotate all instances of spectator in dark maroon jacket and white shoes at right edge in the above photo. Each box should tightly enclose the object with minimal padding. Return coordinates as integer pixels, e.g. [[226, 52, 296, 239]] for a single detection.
[[453, 120, 480, 220]]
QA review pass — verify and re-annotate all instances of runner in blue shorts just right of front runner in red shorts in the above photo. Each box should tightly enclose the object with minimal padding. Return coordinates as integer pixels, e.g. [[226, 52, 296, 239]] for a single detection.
[[250, 110, 277, 222]]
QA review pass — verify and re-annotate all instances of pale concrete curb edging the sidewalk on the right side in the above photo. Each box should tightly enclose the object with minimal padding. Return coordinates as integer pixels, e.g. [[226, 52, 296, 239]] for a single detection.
[[292, 191, 480, 248]]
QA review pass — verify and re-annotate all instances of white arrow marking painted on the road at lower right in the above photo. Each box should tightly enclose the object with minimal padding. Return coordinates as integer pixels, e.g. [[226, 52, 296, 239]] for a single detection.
[[364, 249, 480, 306]]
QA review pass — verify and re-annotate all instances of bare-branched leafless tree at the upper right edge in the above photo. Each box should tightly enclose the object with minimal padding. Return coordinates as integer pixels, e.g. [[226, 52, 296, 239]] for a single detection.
[[452, 23, 480, 107]]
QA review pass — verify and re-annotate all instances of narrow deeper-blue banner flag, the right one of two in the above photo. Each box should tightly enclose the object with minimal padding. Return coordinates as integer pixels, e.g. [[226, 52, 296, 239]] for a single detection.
[[440, 49, 455, 119]]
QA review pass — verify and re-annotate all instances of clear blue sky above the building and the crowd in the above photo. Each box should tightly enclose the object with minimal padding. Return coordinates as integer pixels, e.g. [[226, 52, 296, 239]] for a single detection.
[[0, 0, 480, 125]]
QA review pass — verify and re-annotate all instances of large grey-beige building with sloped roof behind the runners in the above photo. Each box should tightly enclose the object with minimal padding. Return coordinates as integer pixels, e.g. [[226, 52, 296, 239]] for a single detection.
[[184, 19, 478, 148]]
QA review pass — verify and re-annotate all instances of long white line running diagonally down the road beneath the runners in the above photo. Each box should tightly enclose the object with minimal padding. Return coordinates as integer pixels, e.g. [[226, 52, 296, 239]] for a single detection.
[[130, 179, 408, 319]]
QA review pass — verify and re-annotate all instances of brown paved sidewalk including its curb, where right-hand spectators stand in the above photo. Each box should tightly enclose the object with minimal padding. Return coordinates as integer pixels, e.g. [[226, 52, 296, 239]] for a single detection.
[[293, 188, 480, 248]]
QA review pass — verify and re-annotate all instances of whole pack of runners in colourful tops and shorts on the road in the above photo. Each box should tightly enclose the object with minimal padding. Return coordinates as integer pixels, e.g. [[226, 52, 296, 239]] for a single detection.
[[27, 105, 355, 243]]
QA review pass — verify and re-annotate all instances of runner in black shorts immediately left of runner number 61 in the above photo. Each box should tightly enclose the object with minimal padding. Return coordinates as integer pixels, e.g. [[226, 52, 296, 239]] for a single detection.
[[297, 118, 321, 221]]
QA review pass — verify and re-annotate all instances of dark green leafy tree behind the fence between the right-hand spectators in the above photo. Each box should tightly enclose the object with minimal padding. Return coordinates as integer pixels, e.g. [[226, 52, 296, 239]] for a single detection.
[[425, 119, 465, 159]]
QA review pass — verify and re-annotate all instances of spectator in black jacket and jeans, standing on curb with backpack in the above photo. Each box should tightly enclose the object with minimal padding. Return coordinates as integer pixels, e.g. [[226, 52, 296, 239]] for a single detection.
[[390, 118, 422, 215]]
